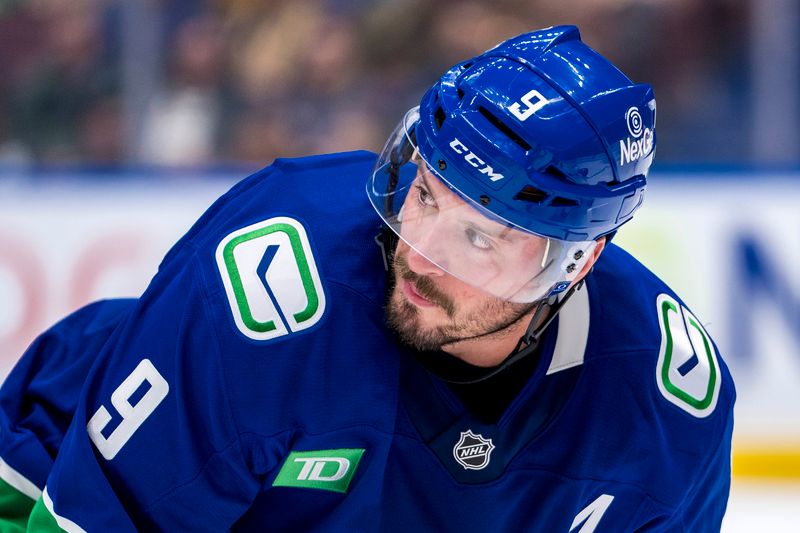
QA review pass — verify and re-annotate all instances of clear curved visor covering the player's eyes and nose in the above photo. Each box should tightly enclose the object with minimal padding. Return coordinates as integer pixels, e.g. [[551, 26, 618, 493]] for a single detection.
[[367, 108, 595, 303]]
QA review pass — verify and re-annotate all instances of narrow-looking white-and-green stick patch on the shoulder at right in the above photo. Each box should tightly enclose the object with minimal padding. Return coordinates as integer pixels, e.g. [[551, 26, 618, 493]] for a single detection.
[[656, 294, 722, 418]]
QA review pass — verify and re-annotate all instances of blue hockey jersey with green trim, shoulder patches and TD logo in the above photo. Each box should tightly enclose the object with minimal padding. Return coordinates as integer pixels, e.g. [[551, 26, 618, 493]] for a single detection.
[[0, 152, 735, 533]]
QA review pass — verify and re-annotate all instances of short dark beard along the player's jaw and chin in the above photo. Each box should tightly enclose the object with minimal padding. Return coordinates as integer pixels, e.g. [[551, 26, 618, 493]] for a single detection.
[[386, 252, 537, 351]]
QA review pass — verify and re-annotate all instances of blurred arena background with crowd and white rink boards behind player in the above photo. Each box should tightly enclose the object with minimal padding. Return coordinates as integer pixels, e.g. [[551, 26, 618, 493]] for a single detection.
[[0, 0, 800, 532]]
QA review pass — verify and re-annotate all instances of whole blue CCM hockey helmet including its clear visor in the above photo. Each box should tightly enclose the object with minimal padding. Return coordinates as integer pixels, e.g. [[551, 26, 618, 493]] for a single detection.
[[367, 26, 656, 302]]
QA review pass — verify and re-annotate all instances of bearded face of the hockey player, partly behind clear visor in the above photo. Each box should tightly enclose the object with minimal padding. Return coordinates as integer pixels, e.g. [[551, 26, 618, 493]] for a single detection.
[[387, 174, 543, 356]]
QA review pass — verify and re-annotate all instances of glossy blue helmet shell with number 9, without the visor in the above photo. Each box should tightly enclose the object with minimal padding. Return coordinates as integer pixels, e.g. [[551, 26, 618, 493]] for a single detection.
[[414, 26, 656, 241]]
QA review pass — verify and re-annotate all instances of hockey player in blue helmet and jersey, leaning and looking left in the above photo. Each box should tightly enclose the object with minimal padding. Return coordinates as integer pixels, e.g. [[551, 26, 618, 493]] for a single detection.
[[0, 27, 735, 533]]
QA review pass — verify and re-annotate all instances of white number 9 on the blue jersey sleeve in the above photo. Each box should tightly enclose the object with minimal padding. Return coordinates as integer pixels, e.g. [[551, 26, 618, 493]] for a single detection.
[[86, 359, 169, 461]]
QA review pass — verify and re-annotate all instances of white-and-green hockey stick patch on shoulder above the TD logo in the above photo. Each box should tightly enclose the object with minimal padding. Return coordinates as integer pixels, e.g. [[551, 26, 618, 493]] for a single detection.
[[216, 217, 325, 340]]
